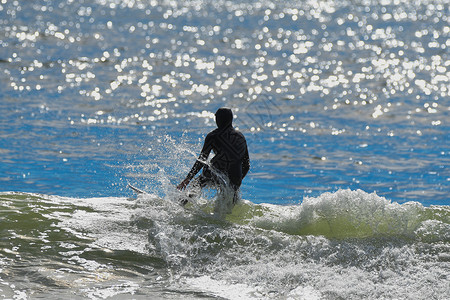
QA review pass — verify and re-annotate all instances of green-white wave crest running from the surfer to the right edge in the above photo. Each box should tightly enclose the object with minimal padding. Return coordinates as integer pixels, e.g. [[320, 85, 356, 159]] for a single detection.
[[229, 190, 450, 242]]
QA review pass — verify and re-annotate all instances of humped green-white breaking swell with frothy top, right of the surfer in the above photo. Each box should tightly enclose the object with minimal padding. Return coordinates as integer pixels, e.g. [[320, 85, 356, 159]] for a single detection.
[[250, 190, 425, 238]]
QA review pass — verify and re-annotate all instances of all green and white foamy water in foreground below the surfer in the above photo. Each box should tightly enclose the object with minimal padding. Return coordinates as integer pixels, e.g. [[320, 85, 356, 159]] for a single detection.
[[0, 190, 450, 299]]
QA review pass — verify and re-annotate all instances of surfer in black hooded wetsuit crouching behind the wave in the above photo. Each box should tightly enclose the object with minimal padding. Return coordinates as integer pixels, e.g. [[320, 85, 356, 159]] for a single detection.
[[177, 108, 250, 204]]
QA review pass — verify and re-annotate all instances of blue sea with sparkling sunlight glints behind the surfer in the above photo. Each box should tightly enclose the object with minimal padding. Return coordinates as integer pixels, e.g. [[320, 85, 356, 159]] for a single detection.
[[0, 1, 450, 204]]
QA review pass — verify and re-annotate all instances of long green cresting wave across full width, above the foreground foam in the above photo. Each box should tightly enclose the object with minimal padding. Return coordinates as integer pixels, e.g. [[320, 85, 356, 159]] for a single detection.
[[0, 190, 450, 246]]
